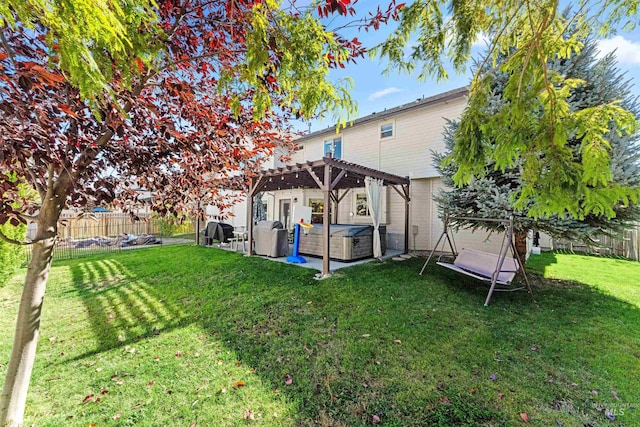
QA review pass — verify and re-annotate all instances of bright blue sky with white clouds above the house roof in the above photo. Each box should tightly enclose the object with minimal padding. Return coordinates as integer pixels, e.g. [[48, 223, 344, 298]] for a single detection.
[[295, 6, 640, 132]]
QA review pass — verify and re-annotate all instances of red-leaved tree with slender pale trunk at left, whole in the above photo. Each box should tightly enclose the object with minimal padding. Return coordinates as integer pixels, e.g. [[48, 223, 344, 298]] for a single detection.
[[0, 0, 384, 425]]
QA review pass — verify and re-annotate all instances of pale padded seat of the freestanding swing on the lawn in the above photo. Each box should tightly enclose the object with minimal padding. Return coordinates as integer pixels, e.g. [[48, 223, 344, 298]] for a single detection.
[[437, 249, 518, 285]]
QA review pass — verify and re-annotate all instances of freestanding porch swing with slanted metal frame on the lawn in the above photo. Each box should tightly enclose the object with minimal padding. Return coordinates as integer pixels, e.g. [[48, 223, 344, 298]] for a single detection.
[[420, 215, 533, 306]]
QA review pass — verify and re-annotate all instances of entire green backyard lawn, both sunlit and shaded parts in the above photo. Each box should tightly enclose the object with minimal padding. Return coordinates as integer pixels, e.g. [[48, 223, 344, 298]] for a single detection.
[[0, 246, 640, 427]]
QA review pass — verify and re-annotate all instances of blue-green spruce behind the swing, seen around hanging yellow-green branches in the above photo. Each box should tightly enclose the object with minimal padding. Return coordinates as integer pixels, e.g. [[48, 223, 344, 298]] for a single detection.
[[433, 38, 640, 249]]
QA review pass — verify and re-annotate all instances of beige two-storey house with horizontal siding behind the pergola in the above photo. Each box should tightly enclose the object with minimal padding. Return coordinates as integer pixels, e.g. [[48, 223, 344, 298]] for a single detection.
[[215, 87, 524, 258]]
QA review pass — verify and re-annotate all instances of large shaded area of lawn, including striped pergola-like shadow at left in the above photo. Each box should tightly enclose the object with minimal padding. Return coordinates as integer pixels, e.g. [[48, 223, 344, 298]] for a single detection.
[[53, 250, 640, 426]]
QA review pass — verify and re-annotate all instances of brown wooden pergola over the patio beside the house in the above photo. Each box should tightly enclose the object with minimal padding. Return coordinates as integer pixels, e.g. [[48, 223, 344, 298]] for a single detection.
[[247, 157, 411, 276]]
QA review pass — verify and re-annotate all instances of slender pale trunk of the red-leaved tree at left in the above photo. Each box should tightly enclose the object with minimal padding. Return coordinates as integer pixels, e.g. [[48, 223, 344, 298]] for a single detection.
[[0, 190, 62, 427]]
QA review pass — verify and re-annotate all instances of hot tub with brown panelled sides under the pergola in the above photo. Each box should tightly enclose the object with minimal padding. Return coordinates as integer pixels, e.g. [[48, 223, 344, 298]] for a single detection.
[[299, 224, 387, 262]]
